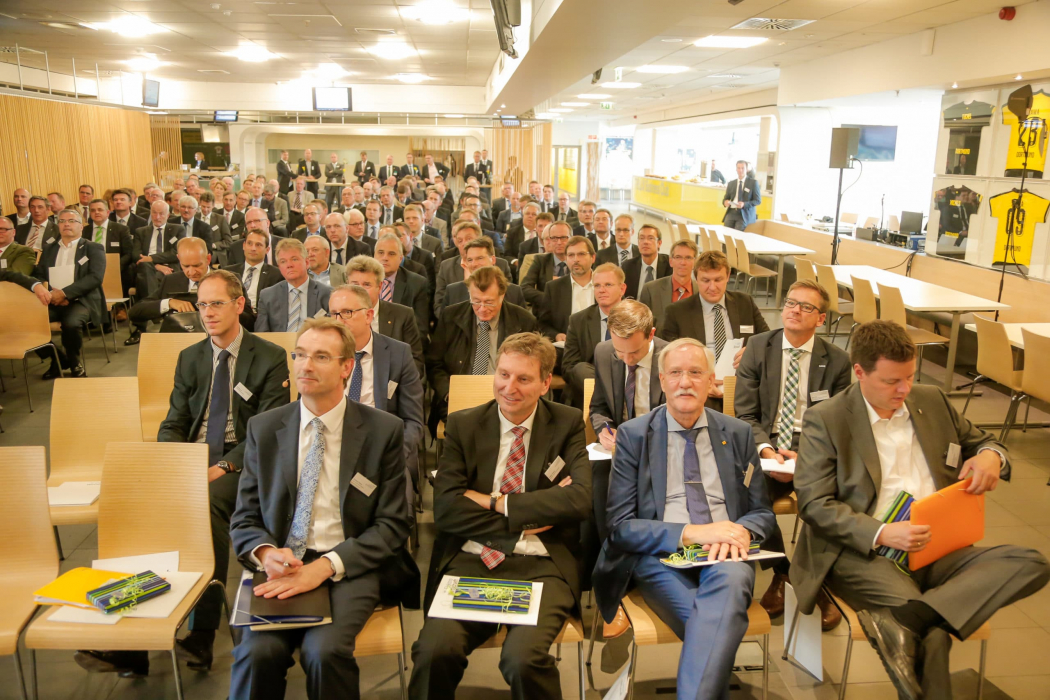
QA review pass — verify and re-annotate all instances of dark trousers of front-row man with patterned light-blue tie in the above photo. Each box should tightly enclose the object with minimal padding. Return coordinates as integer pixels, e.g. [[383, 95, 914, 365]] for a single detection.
[[230, 552, 382, 700]]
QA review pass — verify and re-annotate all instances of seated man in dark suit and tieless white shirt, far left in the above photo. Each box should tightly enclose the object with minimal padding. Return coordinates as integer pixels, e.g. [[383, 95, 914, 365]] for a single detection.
[[33, 207, 106, 379]]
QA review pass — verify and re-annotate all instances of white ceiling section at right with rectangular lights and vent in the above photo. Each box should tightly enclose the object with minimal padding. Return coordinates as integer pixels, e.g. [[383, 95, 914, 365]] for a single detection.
[[536, 0, 1033, 121]]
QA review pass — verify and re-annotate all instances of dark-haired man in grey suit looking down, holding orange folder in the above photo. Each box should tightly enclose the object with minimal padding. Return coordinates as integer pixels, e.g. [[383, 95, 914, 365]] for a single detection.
[[791, 321, 1050, 699]]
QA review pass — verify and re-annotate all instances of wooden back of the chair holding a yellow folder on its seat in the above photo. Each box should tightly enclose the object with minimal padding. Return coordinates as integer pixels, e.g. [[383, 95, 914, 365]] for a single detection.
[[99, 442, 215, 577]]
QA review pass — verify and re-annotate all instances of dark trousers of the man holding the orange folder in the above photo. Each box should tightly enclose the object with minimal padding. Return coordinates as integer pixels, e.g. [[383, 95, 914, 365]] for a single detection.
[[831, 545, 1050, 700]]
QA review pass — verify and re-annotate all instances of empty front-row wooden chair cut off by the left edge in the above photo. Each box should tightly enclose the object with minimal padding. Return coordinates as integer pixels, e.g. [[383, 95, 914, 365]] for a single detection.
[[0, 446, 59, 700]]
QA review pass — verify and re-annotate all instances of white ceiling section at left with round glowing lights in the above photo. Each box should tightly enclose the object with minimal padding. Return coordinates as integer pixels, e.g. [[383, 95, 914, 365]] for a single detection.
[[0, 0, 499, 86]]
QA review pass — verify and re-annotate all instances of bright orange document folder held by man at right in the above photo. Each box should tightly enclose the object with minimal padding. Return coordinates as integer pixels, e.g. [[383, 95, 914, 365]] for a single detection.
[[908, 479, 984, 571]]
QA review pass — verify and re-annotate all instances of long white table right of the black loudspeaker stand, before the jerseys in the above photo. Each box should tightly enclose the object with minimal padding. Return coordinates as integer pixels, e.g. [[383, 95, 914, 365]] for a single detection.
[[828, 264, 1010, 394]]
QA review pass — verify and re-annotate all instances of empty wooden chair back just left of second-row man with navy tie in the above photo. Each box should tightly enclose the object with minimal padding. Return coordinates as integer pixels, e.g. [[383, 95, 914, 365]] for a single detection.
[[137, 333, 207, 442]]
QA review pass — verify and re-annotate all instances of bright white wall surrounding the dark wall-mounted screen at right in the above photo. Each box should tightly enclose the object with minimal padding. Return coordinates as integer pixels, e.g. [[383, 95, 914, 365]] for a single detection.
[[774, 90, 942, 224]]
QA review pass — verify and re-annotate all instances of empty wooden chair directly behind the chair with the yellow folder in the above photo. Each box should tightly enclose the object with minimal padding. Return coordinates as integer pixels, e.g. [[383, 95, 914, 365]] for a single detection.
[[47, 377, 142, 537]]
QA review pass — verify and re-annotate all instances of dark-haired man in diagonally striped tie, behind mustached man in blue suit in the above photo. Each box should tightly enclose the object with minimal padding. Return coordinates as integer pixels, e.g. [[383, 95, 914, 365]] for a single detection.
[[656, 251, 770, 410]]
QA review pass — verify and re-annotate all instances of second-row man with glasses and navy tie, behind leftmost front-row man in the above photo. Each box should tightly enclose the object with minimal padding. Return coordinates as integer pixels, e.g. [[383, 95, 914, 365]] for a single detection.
[[75, 270, 290, 678]]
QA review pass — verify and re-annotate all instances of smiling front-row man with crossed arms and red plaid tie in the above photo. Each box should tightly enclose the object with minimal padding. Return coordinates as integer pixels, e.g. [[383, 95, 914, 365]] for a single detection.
[[408, 333, 591, 700]]
